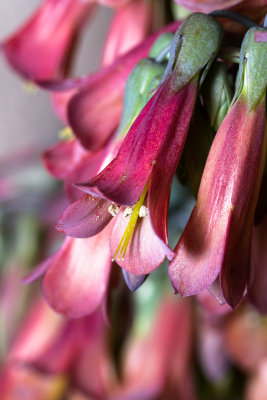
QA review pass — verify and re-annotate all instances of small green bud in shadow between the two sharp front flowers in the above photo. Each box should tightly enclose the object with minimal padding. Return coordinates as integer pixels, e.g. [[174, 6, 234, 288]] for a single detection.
[[202, 62, 232, 131]]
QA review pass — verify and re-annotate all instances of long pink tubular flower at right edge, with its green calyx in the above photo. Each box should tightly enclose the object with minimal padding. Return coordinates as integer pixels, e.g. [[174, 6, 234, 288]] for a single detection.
[[169, 29, 266, 307]]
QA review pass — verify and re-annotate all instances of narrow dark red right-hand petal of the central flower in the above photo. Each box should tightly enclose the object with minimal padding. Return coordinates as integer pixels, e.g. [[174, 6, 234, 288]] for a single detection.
[[148, 84, 197, 260]]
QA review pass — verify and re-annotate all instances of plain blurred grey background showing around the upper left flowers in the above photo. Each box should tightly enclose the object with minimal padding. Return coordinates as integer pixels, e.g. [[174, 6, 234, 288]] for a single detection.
[[0, 0, 113, 159]]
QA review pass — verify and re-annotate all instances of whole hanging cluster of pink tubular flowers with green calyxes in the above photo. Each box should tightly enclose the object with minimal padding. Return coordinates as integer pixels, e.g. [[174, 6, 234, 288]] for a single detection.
[[0, 0, 267, 400]]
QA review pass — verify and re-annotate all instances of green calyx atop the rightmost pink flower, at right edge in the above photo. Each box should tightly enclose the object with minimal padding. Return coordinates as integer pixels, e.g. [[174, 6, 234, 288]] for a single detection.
[[235, 28, 267, 111]]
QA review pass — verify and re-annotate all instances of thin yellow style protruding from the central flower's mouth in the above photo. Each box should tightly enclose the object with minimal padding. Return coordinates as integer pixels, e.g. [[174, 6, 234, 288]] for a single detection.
[[112, 182, 148, 261]]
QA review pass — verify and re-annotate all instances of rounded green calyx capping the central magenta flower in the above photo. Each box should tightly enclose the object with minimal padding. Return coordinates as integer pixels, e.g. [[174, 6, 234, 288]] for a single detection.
[[168, 13, 223, 92]]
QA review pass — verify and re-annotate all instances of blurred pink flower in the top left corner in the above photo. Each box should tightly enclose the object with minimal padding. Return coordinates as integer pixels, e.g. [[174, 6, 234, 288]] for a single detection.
[[2, 0, 93, 81]]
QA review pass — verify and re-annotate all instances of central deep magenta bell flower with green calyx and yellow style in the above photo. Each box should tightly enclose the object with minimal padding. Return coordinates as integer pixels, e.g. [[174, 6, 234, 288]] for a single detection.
[[79, 14, 224, 275]]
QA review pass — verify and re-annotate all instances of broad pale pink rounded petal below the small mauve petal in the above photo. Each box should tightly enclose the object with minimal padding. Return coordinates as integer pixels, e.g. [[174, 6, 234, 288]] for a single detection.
[[42, 227, 111, 318]]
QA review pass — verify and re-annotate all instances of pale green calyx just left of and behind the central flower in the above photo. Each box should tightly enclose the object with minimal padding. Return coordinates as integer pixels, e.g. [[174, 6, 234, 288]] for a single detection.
[[117, 58, 165, 137]]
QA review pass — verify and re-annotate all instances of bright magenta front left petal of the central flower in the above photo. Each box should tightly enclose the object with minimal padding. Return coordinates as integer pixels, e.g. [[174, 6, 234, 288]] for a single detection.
[[81, 76, 196, 205]]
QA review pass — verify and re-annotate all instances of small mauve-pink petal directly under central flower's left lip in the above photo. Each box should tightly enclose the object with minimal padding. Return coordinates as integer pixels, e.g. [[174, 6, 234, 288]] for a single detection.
[[57, 194, 112, 238]]
